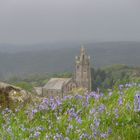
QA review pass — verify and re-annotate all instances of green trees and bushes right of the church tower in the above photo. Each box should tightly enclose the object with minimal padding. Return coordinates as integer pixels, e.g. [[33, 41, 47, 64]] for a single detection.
[[92, 65, 140, 90]]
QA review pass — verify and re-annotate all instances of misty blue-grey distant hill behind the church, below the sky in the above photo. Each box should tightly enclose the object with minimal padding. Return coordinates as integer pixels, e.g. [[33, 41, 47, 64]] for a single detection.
[[0, 42, 140, 77]]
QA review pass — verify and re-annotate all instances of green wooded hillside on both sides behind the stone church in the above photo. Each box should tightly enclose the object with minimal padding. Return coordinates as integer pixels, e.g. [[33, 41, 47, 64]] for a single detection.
[[6, 65, 140, 91]]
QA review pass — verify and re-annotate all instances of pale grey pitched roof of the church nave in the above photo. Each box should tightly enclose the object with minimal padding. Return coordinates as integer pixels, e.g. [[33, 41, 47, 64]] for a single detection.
[[44, 78, 72, 90]]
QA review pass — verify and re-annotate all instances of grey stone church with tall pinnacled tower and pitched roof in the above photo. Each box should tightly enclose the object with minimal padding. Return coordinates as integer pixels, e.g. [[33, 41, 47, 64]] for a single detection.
[[36, 47, 91, 97]]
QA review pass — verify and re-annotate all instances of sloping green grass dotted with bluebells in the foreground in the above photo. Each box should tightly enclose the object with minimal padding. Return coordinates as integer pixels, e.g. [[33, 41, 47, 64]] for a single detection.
[[0, 83, 140, 140]]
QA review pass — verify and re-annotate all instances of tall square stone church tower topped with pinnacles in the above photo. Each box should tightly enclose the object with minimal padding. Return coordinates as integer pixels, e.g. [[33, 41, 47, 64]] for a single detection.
[[75, 46, 91, 91]]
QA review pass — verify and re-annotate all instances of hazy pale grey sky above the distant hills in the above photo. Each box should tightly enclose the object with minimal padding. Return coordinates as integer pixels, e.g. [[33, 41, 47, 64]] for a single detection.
[[0, 0, 140, 44]]
